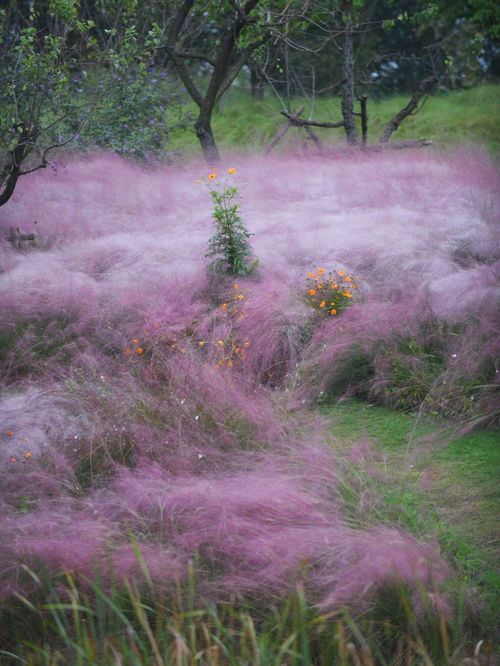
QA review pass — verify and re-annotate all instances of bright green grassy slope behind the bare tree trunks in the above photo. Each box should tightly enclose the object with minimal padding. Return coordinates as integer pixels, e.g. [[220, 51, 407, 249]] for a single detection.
[[170, 84, 500, 155]]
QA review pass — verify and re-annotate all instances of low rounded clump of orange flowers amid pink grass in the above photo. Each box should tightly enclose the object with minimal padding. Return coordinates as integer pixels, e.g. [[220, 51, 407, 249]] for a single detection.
[[306, 268, 358, 316]]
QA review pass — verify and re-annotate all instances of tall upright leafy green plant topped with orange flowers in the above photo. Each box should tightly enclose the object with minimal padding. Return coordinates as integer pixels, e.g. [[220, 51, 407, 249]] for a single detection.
[[202, 168, 258, 276]]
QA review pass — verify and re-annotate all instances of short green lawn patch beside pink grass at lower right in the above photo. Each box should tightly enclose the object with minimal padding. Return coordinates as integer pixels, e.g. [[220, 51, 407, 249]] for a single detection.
[[321, 400, 500, 626]]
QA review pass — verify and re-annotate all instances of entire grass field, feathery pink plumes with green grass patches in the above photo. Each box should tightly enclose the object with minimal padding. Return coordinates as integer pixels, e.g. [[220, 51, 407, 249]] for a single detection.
[[0, 87, 500, 666]]
